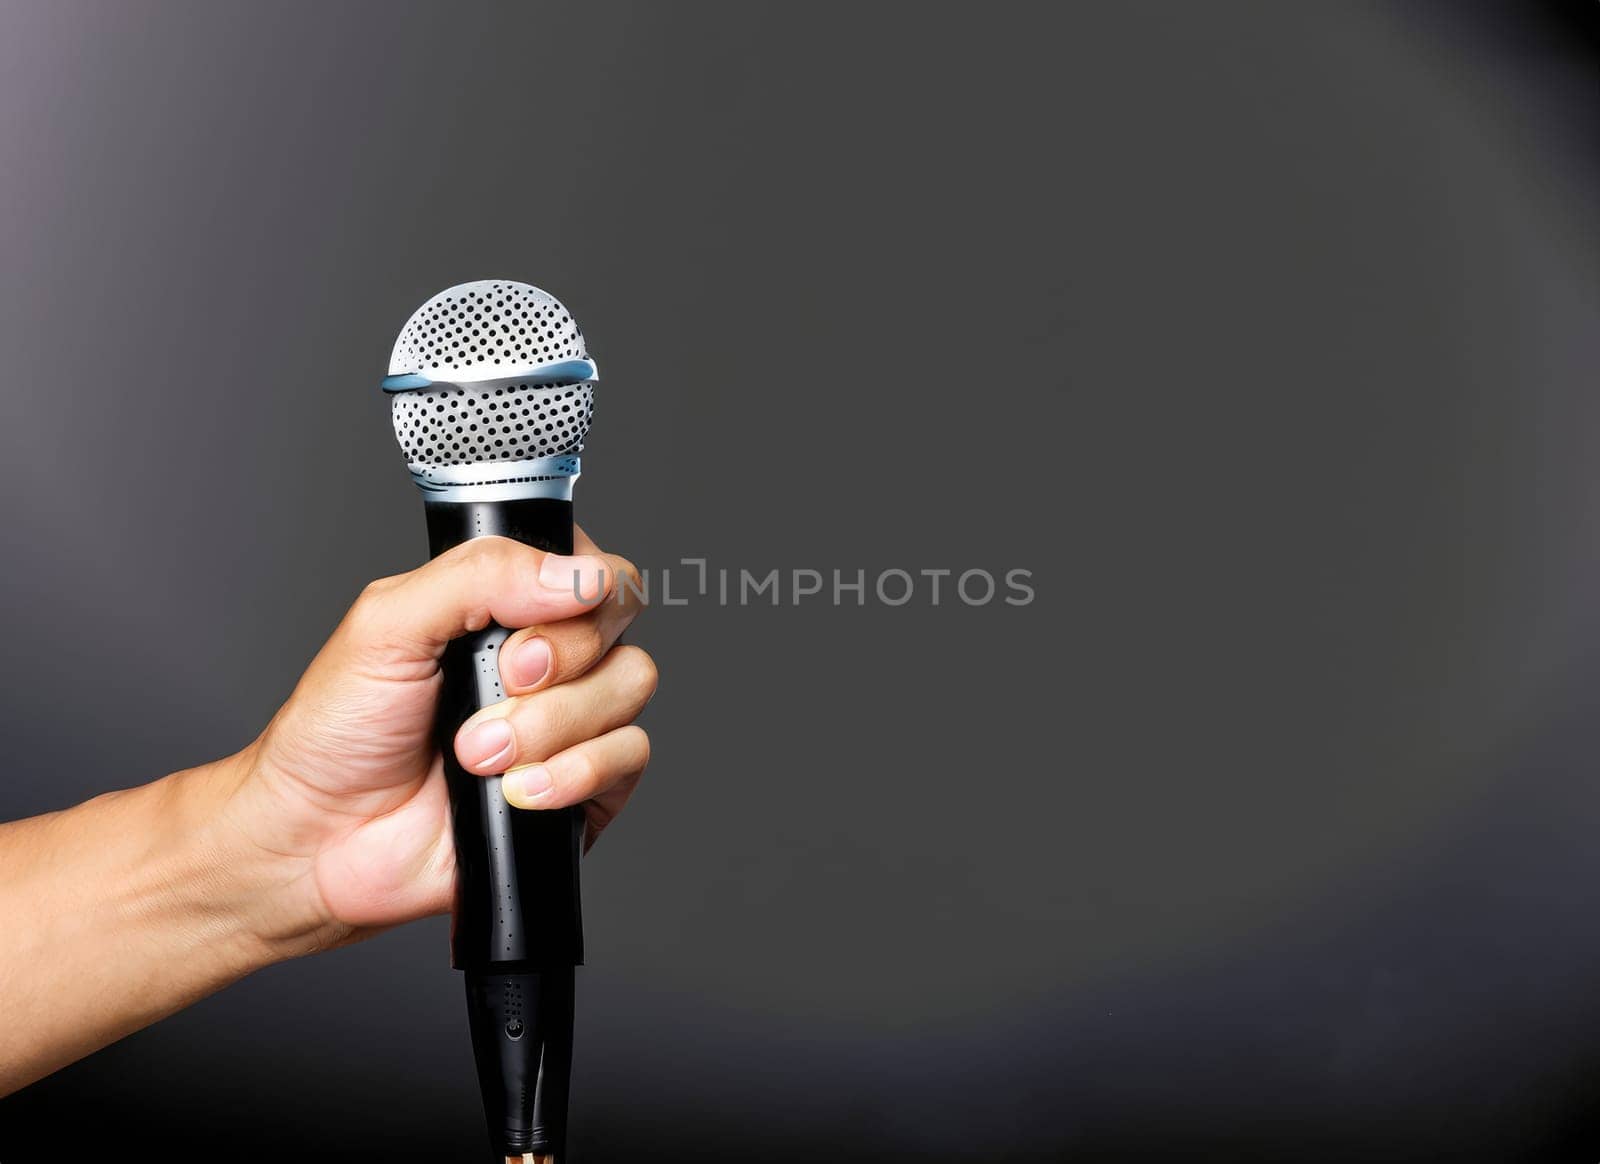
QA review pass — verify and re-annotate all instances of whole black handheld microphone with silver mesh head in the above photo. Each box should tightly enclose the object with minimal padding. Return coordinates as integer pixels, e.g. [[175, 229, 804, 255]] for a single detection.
[[382, 280, 598, 1164]]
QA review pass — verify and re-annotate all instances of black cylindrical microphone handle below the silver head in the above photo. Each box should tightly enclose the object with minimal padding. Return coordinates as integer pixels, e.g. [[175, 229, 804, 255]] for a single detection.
[[426, 497, 584, 1156]]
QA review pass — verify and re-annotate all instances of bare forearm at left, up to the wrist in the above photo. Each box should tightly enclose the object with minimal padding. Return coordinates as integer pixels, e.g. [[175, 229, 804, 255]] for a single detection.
[[0, 755, 308, 1094]]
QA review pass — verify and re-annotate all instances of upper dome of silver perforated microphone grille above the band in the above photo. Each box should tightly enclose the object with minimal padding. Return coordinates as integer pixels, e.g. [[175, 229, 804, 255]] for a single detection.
[[389, 278, 589, 379]]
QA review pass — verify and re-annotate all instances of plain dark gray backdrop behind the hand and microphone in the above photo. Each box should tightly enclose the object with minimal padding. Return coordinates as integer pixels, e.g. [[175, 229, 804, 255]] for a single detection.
[[0, 0, 1600, 1164]]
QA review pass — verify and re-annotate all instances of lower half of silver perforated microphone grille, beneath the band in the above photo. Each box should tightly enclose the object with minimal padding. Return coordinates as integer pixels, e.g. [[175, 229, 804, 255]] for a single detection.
[[392, 381, 595, 465]]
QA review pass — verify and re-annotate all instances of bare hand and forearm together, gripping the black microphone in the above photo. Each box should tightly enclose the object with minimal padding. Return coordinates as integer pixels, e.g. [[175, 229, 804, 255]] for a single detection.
[[0, 531, 656, 1095]]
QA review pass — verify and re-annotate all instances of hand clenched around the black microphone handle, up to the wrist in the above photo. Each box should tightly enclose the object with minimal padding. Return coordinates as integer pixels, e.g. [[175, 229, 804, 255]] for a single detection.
[[212, 531, 656, 948]]
